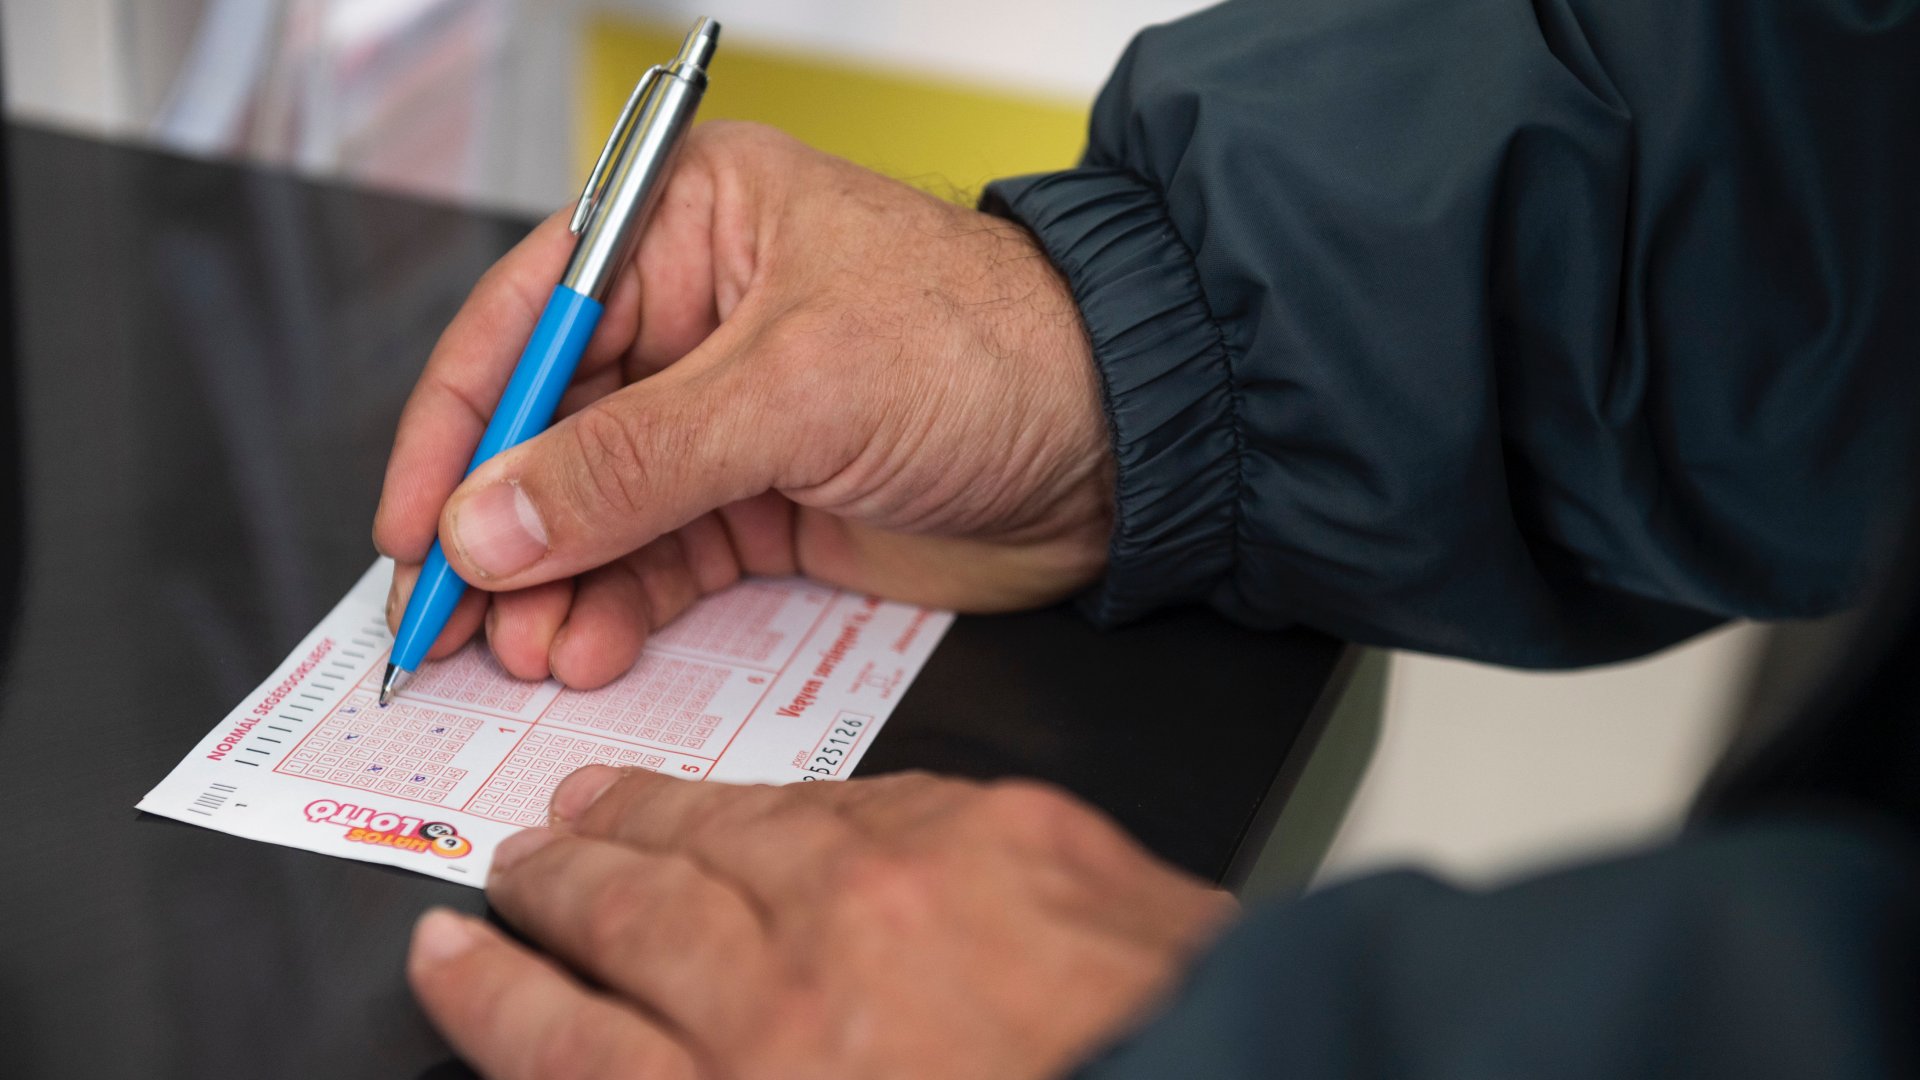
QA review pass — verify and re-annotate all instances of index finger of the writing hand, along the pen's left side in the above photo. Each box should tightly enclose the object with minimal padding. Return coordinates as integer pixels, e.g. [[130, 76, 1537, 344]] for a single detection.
[[372, 211, 636, 563]]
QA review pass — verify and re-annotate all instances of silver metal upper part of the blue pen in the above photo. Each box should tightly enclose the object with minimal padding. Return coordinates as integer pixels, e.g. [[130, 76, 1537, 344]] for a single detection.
[[561, 17, 720, 300]]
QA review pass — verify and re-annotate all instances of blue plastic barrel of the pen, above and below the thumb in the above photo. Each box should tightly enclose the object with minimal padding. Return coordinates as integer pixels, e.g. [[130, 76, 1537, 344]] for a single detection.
[[392, 284, 601, 671]]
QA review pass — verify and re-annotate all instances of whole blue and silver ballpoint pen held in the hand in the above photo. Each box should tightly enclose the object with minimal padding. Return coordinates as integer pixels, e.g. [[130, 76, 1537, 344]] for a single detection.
[[380, 17, 720, 705]]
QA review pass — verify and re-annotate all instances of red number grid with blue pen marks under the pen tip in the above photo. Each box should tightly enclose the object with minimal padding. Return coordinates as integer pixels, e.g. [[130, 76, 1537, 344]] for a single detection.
[[276, 694, 480, 803]]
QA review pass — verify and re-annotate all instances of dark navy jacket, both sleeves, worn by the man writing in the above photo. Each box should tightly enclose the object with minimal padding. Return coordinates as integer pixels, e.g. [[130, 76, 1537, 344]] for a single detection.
[[987, 0, 1920, 1080]]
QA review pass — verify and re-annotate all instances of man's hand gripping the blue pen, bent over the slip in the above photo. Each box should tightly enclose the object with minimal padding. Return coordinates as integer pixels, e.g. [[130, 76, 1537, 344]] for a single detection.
[[374, 123, 1112, 688]]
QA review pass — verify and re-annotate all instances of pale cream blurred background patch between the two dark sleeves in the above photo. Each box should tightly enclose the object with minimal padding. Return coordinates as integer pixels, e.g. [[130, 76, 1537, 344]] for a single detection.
[[1319, 625, 1763, 882]]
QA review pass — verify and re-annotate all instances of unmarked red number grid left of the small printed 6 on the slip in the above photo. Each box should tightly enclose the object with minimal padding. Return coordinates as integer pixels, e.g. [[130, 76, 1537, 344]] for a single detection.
[[541, 655, 728, 749]]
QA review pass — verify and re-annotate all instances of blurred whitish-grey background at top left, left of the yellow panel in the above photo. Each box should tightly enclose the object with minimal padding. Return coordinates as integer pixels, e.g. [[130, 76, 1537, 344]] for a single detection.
[[0, 0, 578, 211]]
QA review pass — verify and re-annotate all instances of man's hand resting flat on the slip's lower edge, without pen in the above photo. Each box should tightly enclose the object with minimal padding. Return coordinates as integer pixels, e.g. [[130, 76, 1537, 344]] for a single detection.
[[407, 765, 1235, 1080]]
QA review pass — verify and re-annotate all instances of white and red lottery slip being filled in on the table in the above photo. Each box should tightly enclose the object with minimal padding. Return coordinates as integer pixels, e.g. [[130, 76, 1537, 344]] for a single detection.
[[140, 559, 952, 886]]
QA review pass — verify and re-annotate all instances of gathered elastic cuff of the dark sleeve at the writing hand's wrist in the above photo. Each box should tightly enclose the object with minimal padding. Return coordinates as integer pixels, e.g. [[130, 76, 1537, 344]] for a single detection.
[[981, 167, 1240, 625]]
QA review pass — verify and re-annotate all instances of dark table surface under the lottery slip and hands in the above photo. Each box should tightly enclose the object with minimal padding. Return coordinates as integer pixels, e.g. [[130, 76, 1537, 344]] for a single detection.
[[0, 127, 1344, 1078]]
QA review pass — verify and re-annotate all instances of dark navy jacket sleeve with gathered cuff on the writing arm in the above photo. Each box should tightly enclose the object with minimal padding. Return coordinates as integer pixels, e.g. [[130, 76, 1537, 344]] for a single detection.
[[985, 0, 1920, 667]]
